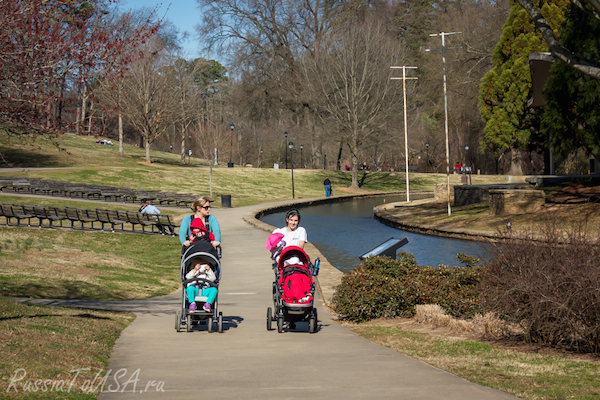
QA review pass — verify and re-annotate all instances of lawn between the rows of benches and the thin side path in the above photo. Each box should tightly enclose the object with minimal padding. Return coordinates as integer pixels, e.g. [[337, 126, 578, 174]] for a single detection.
[[0, 228, 181, 300]]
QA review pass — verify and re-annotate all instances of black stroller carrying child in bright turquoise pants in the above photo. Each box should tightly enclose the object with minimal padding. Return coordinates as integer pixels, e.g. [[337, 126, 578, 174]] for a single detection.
[[175, 240, 223, 333]]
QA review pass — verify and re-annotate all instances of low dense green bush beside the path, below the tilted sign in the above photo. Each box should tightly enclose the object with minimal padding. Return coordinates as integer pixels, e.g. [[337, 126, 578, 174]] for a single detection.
[[333, 253, 481, 322]]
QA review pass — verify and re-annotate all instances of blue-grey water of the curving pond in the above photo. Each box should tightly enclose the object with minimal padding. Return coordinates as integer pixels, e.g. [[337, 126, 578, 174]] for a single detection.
[[261, 196, 489, 272]]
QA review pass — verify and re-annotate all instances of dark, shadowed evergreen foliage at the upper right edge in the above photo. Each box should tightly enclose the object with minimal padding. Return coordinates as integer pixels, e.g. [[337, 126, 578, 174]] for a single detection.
[[542, 4, 600, 158]]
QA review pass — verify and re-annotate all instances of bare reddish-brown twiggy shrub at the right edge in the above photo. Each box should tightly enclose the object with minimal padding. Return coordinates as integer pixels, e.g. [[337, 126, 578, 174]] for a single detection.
[[481, 211, 600, 352]]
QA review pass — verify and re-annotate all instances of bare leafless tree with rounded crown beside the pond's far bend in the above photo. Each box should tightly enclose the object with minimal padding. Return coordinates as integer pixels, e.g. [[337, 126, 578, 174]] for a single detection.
[[304, 21, 402, 188]]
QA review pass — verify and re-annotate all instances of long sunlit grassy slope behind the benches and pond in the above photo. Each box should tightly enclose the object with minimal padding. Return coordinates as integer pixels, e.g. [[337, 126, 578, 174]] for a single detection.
[[0, 135, 502, 207]]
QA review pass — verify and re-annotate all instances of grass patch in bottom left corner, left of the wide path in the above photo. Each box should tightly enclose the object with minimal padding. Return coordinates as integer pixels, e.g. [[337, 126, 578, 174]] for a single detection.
[[0, 297, 135, 400]]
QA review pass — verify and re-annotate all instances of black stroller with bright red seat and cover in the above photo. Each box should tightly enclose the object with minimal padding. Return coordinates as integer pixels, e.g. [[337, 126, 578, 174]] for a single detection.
[[267, 246, 319, 333]]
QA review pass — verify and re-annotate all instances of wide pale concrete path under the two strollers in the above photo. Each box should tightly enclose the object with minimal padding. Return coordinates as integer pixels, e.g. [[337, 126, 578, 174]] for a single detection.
[[17, 206, 515, 400]]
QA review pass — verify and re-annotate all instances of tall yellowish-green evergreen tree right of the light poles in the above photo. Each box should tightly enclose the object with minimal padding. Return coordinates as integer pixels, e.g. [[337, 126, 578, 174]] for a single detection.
[[479, 0, 568, 174]]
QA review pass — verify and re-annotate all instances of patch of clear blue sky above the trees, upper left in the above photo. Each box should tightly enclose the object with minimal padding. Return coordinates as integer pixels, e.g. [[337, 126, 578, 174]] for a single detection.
[[119, 0, 206, 58]]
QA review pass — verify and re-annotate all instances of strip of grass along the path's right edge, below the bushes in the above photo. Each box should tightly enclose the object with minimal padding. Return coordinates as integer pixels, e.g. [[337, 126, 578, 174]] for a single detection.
[[350, 324, 600, 400]]
